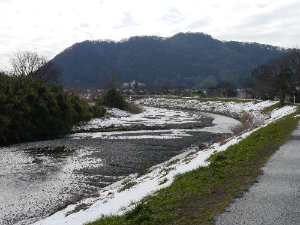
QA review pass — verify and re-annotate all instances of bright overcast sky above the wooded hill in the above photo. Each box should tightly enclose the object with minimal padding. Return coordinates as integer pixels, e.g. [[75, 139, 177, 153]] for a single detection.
[[0, 0, 300, 69]]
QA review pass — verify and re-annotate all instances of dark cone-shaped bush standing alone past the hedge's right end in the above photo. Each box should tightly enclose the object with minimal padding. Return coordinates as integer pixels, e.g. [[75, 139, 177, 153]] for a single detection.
[[96, 87, 128, 109]]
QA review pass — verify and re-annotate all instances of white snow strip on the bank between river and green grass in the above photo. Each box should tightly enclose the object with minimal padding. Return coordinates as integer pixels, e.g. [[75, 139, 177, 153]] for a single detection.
[[35, 100, 295, 225]]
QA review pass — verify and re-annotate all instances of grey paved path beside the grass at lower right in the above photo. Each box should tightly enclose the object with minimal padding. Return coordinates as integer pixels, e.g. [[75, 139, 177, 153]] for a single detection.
[[216, 123, 300, 225]]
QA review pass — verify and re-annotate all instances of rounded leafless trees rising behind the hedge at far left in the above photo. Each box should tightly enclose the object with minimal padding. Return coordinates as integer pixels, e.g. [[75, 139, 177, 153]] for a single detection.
[[10, 51, 61, 83]]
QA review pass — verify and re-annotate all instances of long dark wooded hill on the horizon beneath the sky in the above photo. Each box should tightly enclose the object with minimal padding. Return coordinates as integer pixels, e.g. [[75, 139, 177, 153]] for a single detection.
[[52, 33, 284, 88]]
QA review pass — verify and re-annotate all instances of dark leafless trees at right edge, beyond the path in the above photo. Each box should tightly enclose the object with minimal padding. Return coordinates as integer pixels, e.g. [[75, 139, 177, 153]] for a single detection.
[[245, 48, 300, 106]]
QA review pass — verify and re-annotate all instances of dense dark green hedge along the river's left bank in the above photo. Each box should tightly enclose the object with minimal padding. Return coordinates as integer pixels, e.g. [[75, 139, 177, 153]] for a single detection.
[[0, 73, 105, 144]]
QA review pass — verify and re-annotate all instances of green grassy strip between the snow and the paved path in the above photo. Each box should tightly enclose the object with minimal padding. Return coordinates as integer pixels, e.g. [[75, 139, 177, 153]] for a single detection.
[[85, 111, 299, 225]]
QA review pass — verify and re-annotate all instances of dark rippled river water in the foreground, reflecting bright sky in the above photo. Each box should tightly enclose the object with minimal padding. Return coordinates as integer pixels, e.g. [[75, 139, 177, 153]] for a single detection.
[[0, 121, 223, 225]]
